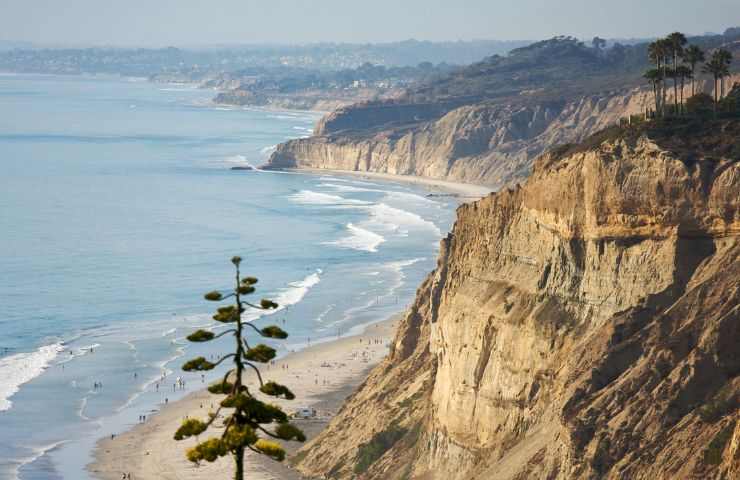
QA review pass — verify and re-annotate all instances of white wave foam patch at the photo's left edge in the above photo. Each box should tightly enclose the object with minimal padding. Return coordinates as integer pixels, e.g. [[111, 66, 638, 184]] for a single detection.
[[0, 343, 64, 412]]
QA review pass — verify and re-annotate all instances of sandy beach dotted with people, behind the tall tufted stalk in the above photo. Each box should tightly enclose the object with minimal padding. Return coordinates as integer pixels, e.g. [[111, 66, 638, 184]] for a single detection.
[[88, 315, 400, 480]]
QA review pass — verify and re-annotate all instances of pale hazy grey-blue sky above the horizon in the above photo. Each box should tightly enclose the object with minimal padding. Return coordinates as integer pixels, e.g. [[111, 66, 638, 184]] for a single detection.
[[0, 0, 740, 46]]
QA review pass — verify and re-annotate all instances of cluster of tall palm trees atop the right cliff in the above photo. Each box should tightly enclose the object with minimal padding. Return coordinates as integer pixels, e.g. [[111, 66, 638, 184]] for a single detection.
[[643, 32, 732, 117]]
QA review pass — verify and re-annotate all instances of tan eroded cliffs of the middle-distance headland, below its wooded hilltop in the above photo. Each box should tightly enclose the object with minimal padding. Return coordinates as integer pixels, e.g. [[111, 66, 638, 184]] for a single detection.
[[269, 76, 740, 188]]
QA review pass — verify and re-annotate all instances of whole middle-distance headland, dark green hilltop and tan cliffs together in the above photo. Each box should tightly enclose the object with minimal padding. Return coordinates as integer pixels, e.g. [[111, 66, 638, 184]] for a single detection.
[[268, 36, 740, 188]]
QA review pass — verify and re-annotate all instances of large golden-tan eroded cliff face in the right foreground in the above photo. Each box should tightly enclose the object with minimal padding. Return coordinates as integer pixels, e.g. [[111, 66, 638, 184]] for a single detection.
[[298, 132, 740, 480]]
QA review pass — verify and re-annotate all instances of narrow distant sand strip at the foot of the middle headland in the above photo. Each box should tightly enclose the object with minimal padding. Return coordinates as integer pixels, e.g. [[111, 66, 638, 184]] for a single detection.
[[264, 168, 495, 203]]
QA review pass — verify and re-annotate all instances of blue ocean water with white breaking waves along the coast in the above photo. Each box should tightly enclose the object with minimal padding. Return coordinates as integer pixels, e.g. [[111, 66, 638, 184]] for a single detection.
[[0, 76, 455, 480]]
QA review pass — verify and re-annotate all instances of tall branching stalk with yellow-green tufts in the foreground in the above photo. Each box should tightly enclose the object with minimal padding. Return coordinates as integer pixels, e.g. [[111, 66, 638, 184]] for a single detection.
[[175, 257, 306, 480]]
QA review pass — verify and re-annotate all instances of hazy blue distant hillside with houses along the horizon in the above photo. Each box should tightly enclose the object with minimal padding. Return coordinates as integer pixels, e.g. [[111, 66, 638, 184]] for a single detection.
[[0, 40, 528, 81]]
